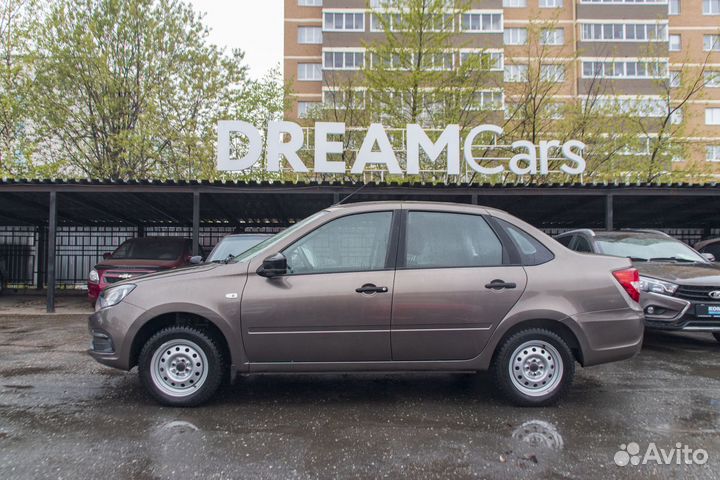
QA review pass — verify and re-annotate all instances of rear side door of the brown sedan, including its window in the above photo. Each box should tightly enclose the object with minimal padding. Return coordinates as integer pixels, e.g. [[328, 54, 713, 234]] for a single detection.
[[391, 210, 527, 361]]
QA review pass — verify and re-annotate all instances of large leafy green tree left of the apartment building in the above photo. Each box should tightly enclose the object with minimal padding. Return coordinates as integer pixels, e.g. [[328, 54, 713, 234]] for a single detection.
[[35, 0, 282, 178]]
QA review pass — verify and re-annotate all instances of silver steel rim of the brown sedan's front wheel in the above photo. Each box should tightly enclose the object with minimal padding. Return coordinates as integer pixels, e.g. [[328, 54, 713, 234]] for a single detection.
[[150, 339, 208, 398]]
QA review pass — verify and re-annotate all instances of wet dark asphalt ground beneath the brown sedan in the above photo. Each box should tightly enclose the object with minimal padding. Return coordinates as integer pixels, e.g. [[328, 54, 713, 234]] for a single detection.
[[0, 315, 720, 479]]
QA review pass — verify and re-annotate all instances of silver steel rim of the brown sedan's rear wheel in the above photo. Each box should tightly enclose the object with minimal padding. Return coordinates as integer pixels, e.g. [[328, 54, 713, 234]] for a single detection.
[[508, 340, 563, 397]]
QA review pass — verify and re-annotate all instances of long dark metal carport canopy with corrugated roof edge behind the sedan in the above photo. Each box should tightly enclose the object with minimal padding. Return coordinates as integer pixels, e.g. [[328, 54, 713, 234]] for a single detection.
[[0, 179, 720, 311]]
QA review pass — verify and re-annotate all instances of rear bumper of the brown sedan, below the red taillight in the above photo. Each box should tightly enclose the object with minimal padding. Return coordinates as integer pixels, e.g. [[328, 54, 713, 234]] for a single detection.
[[571, 309, 645, 367]]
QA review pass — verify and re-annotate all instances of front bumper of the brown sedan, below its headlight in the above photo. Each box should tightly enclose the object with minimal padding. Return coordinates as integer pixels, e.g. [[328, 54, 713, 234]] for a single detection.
[[88, 301, 143, 370]]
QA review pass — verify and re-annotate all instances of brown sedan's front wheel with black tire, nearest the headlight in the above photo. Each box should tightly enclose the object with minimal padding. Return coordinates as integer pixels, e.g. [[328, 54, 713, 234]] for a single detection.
[[138, 327, 226, 407]]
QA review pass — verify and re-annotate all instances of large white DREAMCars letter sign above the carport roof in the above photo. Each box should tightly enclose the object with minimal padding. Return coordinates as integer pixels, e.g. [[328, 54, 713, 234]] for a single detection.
[[217, 120, 585, 175]]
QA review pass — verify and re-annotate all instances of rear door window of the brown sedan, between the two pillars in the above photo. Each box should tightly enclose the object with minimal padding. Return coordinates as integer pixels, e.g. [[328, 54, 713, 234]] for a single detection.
[[405, 212, 503, 268]]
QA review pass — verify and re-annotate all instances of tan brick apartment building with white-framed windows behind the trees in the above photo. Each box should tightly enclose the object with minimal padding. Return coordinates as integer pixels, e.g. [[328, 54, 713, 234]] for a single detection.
[[284, 0, 720, 171]]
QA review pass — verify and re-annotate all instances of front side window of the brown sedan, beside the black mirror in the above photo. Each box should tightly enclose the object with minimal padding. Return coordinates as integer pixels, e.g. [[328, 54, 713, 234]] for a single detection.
[[283, 212, 392, 275]]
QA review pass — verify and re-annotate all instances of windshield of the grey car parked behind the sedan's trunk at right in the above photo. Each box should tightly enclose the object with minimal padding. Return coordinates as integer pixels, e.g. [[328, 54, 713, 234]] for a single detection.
[[595, 235, 707, 263]]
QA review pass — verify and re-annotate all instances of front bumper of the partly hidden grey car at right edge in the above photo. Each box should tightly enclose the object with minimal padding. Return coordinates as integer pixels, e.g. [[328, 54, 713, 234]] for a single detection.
[[640, 292, 720, 332]]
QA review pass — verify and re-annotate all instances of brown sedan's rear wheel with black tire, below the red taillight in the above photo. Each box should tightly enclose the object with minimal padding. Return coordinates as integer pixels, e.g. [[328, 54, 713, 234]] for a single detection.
[[490, 328, 575, 407]]
